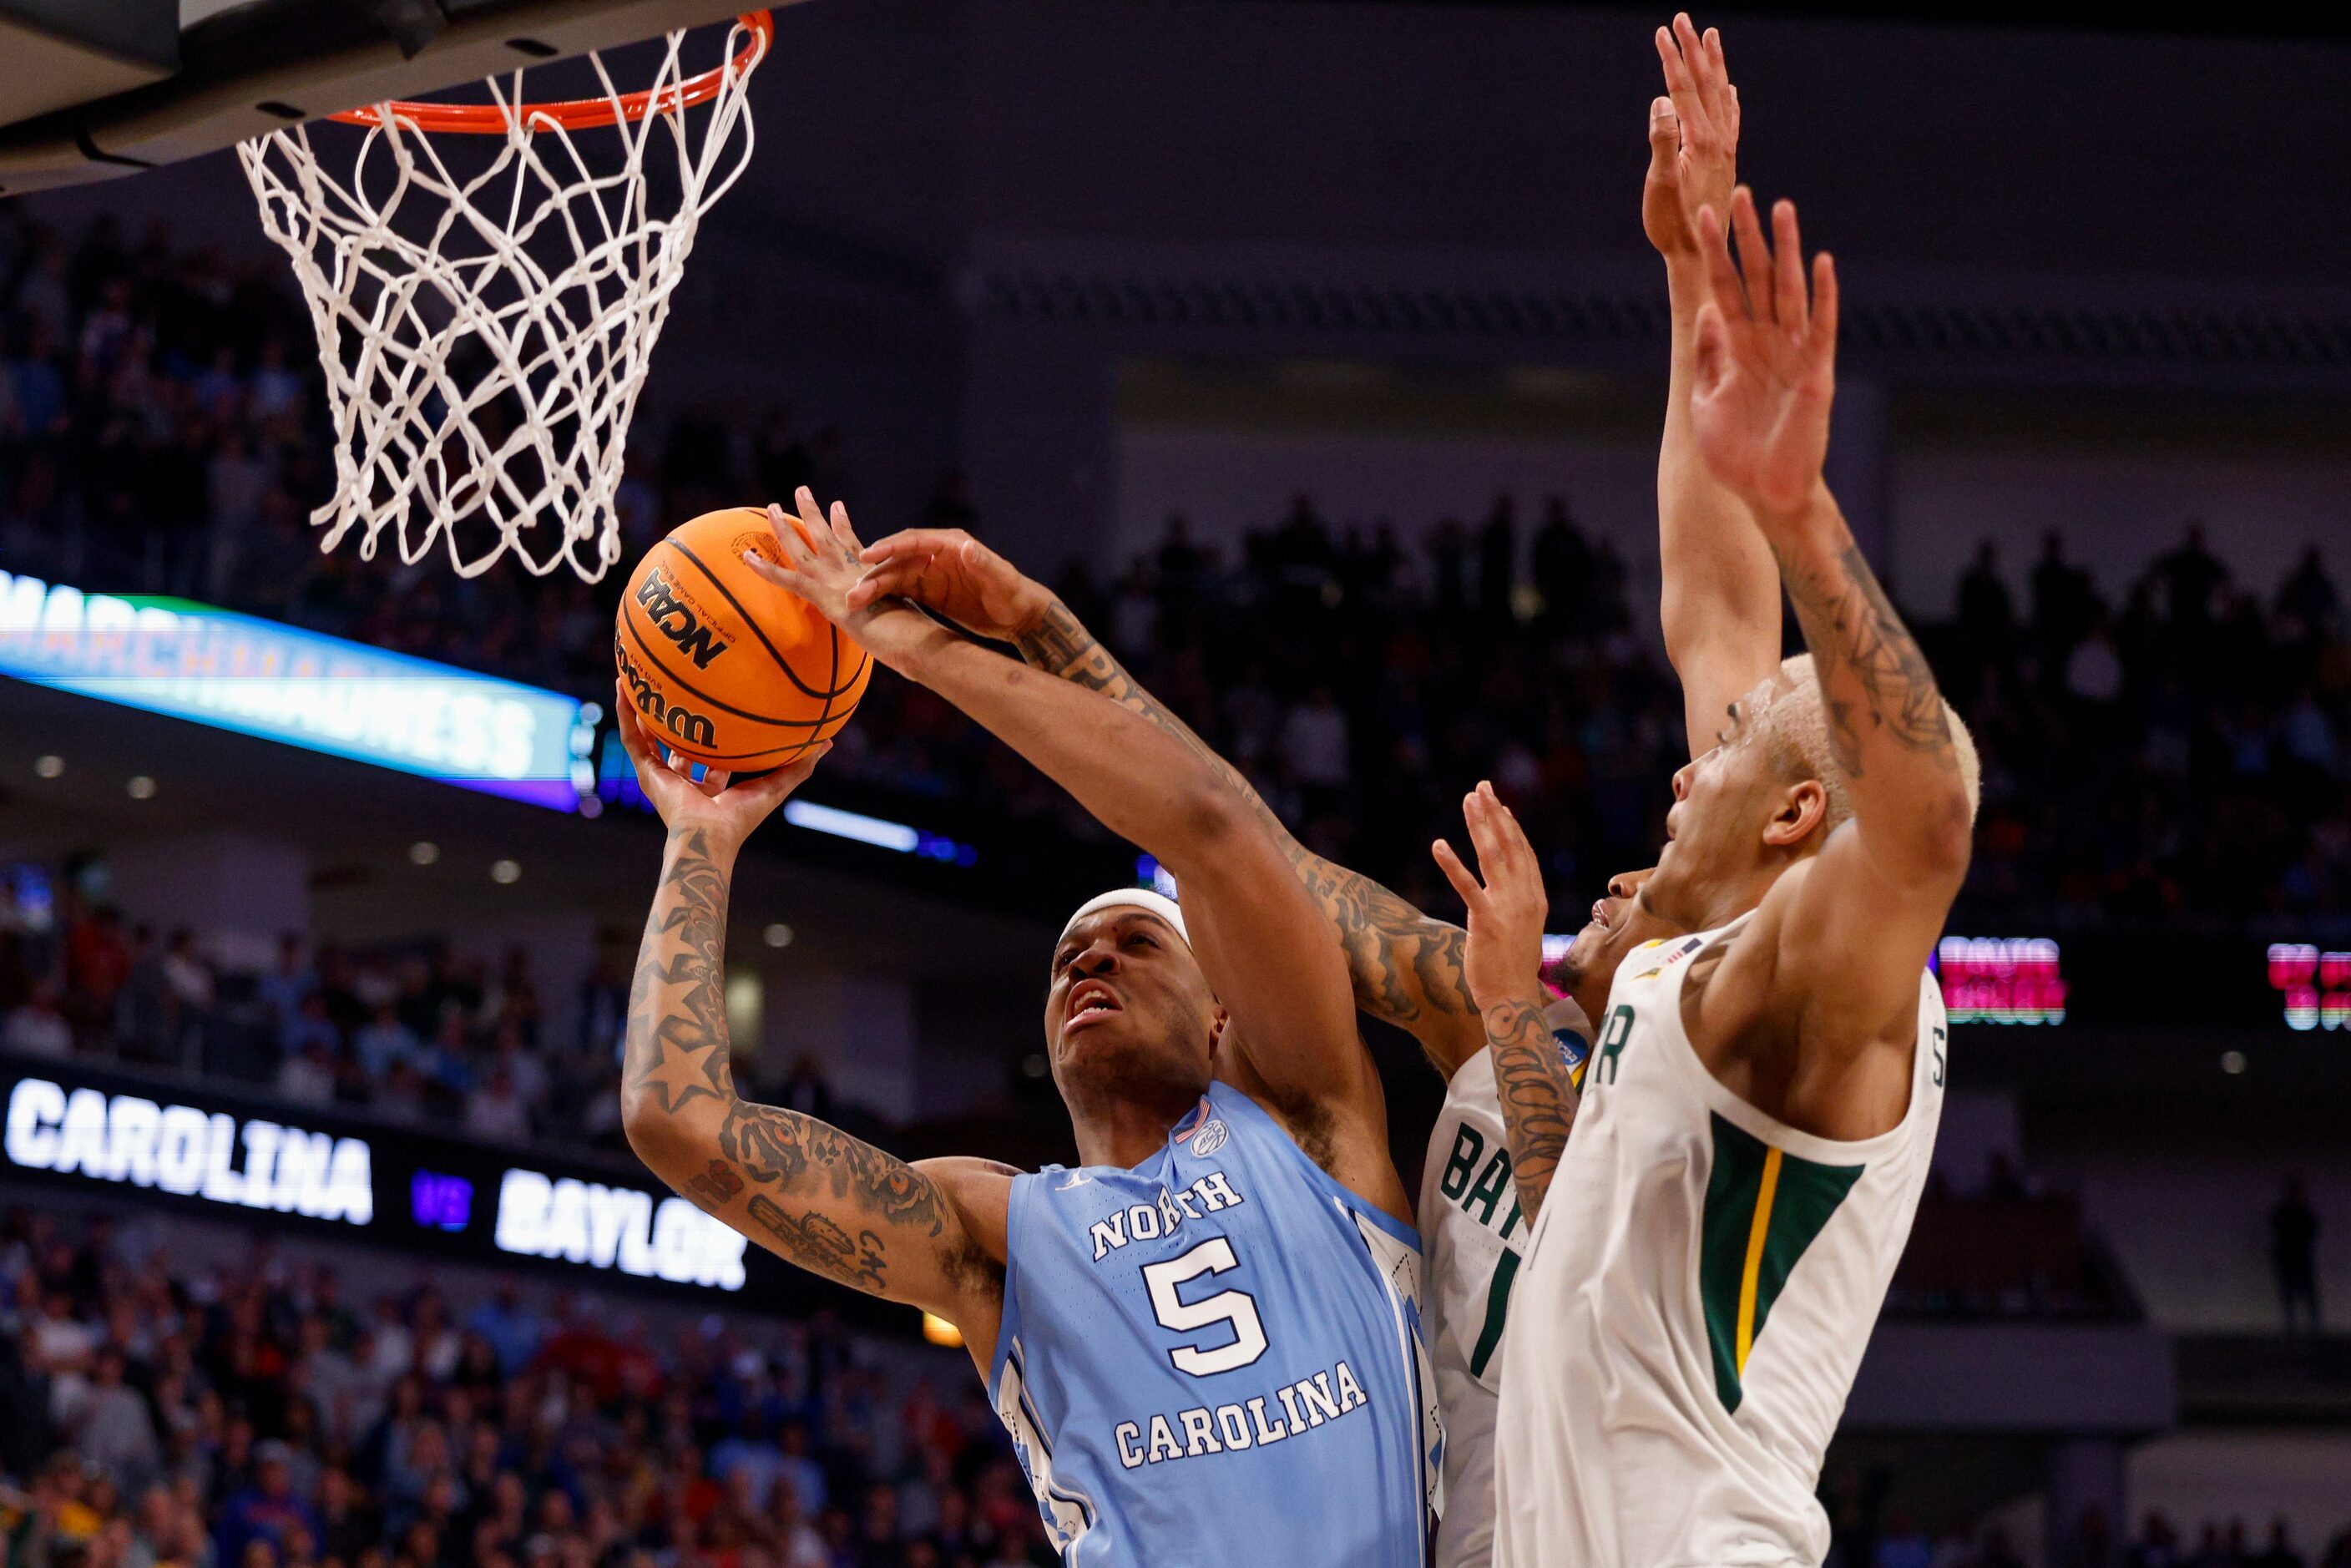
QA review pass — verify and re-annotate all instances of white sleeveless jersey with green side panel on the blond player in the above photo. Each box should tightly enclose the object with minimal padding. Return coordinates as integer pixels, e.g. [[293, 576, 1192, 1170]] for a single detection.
[[1495, 922, 1947, 1568]]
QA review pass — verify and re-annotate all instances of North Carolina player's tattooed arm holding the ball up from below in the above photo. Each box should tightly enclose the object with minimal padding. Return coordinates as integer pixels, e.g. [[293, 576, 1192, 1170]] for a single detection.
[[619, 691, 1011, 1347]]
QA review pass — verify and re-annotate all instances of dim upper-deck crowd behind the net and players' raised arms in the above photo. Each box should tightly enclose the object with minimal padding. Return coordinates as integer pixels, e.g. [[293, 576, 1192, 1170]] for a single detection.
[[0, 205, 2351, 924]]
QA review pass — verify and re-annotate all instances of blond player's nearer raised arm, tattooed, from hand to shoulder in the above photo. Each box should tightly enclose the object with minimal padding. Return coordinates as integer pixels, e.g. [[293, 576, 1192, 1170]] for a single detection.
[[1693, 188, 1973, 1044]]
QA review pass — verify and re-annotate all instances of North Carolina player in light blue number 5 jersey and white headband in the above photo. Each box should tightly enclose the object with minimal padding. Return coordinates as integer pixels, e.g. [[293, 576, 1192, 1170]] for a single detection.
[[620, 509, 1441, 1568]]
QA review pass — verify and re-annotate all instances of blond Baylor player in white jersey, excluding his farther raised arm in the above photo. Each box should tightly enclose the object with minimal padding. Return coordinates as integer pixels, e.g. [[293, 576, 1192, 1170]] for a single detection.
[[1495, 192, 1977, 1568]]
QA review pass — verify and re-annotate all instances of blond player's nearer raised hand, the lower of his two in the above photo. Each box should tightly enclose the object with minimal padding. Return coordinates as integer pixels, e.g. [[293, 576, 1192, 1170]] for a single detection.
[[1691, 185, 1836, 524]]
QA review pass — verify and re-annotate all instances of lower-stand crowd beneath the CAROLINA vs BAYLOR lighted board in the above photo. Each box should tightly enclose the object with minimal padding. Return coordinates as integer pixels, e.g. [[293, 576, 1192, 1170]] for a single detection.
[[0, 1211, 1055, 1568]]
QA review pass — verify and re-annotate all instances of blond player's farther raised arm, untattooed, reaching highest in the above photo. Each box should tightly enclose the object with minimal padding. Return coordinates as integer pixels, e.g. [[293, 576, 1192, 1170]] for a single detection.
[[1641, 14, 1780, 757]]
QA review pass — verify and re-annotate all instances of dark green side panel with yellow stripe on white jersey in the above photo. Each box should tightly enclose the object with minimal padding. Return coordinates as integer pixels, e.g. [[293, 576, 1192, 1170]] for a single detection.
[[1697, 1112, 1864, 1410]]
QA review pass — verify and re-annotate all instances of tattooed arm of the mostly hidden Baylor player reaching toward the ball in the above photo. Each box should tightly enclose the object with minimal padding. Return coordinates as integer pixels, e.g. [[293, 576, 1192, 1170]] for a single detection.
[[853, 529, 1486, 1077]]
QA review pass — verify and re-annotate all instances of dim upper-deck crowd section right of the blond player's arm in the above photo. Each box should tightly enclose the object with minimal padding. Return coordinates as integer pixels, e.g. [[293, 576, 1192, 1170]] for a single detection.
[[1930, 524, 2351, 922]]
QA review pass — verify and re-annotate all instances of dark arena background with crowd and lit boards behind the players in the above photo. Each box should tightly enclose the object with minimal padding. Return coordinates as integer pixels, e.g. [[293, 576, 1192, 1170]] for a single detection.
[[0, 0, 2351, 1568]]
